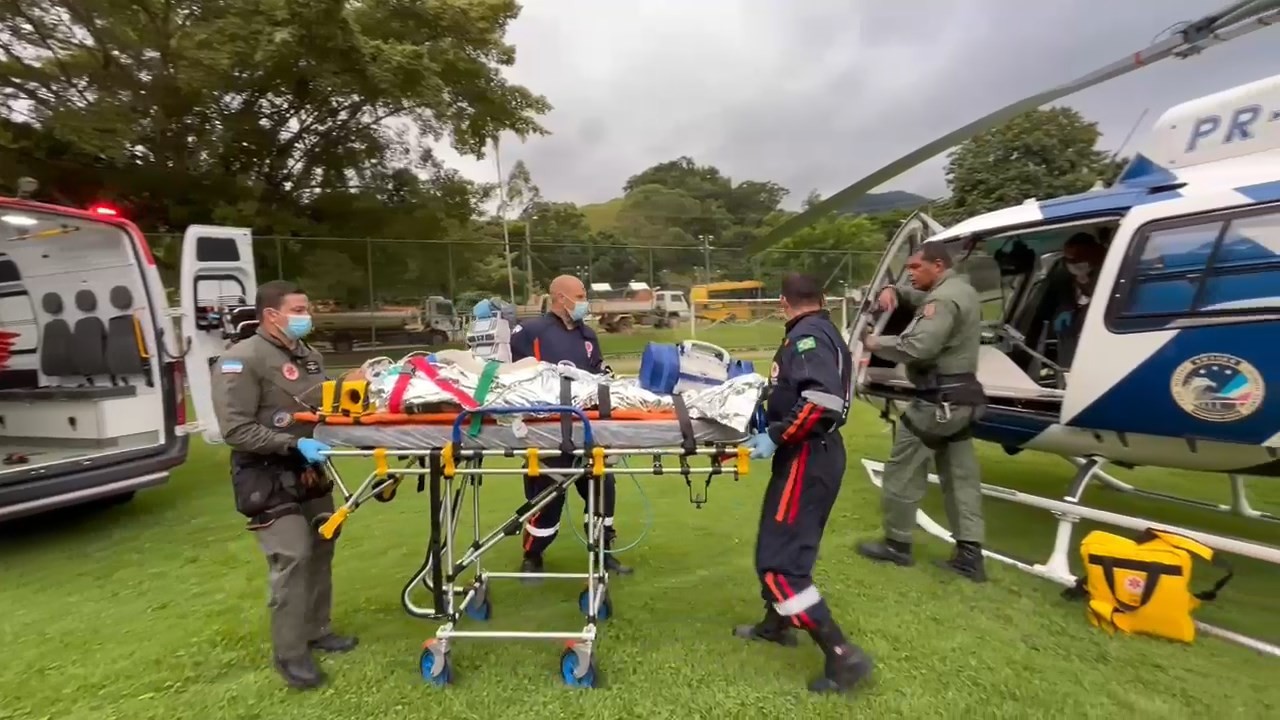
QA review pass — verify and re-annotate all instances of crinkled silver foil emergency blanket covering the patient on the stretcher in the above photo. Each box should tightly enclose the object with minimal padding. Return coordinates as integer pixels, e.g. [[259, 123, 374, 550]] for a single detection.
[[361, 354, 765, 434]]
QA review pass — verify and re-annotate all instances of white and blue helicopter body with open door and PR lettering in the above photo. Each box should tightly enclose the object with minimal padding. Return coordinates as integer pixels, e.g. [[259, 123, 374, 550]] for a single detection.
[[851, 68, 1280, 477]]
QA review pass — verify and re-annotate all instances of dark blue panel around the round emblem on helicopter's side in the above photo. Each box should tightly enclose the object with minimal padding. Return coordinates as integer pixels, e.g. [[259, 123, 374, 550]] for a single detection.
[[1068, 323, 1280, 445]]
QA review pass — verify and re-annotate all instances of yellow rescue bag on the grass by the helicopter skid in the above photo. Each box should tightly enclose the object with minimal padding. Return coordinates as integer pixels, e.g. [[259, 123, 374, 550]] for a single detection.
[[1076, 528, 1233, 643]]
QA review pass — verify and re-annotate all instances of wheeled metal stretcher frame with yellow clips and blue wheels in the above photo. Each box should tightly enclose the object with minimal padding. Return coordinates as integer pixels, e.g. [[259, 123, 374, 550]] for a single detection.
[[316, 406, 749, 688]]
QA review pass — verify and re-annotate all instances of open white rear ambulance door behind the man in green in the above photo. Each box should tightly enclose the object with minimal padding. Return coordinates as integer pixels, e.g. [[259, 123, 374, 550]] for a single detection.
[[179, 225, 257, 443]]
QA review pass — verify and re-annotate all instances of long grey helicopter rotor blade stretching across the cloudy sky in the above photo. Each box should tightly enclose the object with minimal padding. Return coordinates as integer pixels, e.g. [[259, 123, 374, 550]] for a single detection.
[[748, 0, 1280, 254]]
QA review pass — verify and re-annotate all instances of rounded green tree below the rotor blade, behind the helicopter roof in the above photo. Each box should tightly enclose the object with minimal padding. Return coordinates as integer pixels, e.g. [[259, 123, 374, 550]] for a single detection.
[[940, 108, 1119, 222]]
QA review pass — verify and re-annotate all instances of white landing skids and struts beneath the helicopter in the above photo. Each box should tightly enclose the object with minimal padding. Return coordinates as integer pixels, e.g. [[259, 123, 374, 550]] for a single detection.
[[863, 457, 1280, 657]]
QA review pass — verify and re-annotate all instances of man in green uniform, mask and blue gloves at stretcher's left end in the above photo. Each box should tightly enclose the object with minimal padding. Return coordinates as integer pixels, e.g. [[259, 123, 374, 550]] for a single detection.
[[211, 281, 357, 689]]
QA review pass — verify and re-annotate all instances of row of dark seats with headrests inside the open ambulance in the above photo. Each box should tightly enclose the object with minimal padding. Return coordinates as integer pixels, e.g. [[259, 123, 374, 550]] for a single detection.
[[0, 286, 147, 401]]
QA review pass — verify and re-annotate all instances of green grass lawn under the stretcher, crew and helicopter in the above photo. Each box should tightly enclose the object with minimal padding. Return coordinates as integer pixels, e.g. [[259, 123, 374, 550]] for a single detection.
[[0, 406, 1280, 720]]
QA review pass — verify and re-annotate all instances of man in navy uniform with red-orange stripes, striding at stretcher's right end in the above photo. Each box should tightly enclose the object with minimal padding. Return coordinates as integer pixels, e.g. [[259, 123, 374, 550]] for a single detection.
[[733, 273, 872, 692]]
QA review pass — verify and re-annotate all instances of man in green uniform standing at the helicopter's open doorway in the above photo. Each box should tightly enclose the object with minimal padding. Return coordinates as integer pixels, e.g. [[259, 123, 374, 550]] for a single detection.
[[858, 242, 987, 583]]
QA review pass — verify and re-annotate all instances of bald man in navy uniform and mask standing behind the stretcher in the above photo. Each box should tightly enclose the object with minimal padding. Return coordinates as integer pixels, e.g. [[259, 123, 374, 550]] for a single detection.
[[511, 275, 631, 575]]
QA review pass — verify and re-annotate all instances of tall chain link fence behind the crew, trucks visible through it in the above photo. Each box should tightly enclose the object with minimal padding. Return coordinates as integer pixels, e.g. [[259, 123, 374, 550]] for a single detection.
[[148, 233, 879, 352]]
